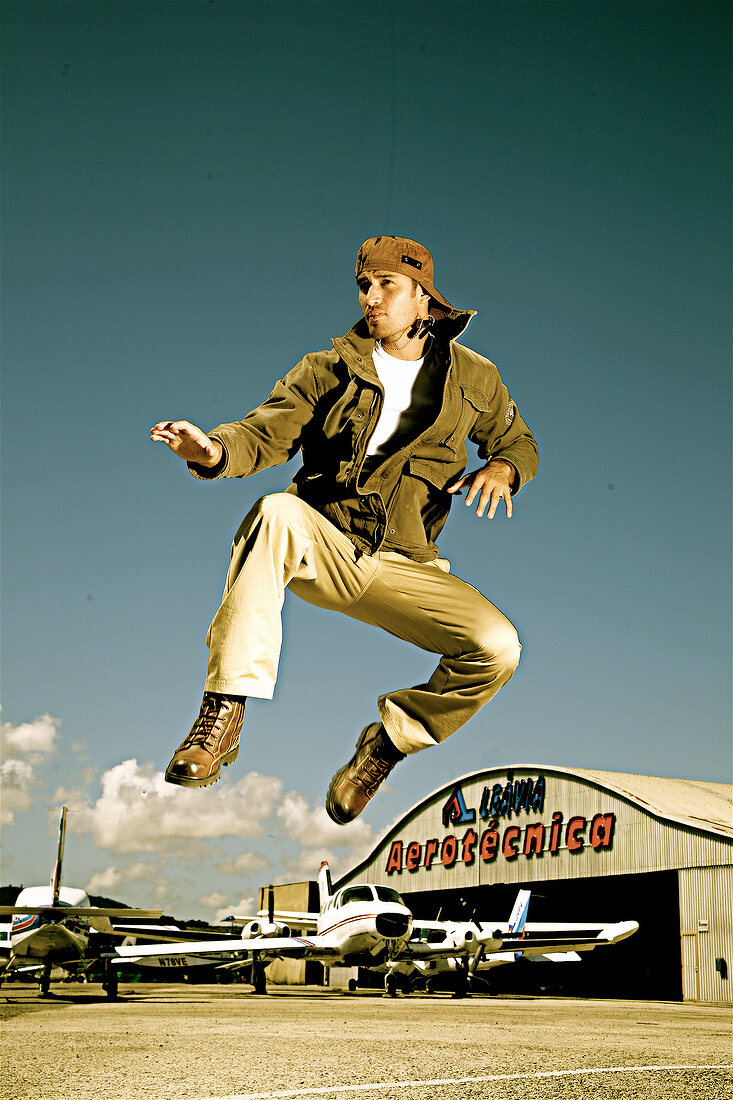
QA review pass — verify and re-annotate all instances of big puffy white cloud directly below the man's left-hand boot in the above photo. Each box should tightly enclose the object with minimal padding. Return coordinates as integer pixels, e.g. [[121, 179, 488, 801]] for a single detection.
[[69, 760, 283, 858]]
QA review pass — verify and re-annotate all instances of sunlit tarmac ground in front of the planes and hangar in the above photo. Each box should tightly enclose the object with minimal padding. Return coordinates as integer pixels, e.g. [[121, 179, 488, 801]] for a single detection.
[[0, 982, 733, 1100]]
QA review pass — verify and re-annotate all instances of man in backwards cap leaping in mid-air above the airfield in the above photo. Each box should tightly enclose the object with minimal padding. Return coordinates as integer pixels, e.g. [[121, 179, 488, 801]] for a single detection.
[[151, 237, 537, 825]]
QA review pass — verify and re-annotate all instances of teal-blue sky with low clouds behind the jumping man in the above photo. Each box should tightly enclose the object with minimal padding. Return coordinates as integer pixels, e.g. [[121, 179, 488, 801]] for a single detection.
[[2, 0, 731, 917]]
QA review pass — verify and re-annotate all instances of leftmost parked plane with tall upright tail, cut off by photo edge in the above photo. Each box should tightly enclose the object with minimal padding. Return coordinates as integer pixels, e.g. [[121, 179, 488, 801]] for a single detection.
[[0, 806, 164, 998]]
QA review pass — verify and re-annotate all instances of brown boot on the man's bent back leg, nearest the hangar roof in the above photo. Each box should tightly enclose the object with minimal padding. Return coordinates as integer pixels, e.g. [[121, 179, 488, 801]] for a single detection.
[[326, 722, 405, 825]]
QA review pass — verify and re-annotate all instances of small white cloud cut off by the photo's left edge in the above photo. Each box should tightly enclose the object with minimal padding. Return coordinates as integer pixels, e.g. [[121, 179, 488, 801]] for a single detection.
[[0, 714, 61, 825]]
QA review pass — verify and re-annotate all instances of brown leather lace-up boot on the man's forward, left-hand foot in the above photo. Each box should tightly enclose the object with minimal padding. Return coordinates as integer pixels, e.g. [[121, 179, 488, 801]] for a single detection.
[[165, 692, 244, 787]]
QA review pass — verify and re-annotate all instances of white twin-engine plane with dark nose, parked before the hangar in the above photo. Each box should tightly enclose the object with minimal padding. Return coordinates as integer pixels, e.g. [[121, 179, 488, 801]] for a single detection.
[[116, 862, 638, 994]]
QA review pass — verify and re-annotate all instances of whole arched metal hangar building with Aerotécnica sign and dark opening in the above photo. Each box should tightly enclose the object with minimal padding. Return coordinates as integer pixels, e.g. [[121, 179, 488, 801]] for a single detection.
[[336, 765, 733, 1003]]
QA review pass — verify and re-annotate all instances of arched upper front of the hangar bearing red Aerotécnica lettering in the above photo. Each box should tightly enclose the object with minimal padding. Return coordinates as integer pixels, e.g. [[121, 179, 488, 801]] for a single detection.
[[341, 766, 733, 890]]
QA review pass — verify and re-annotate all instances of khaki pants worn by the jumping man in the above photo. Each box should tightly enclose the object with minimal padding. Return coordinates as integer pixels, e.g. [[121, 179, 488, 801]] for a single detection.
[[206, 493, 521, 752]]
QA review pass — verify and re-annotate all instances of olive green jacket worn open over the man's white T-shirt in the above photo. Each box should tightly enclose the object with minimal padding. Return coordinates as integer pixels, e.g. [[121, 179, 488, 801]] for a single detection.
[[189, 310, 537, 561]]
